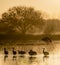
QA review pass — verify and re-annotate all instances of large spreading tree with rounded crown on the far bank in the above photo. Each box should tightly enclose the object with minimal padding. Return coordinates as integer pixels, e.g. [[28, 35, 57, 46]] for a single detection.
[[1, 7, 43, 34]]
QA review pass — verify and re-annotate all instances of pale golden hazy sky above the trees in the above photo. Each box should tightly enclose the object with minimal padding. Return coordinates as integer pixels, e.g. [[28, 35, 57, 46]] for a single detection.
[[0, 0, 60, 18]]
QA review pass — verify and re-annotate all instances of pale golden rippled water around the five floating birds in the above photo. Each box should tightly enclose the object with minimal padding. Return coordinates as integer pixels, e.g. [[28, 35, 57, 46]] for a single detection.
[[0, 41, 60, 65]]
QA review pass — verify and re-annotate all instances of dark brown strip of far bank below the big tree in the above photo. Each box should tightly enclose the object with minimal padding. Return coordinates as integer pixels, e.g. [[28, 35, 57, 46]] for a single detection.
[[0, 34, 60, 40]]
